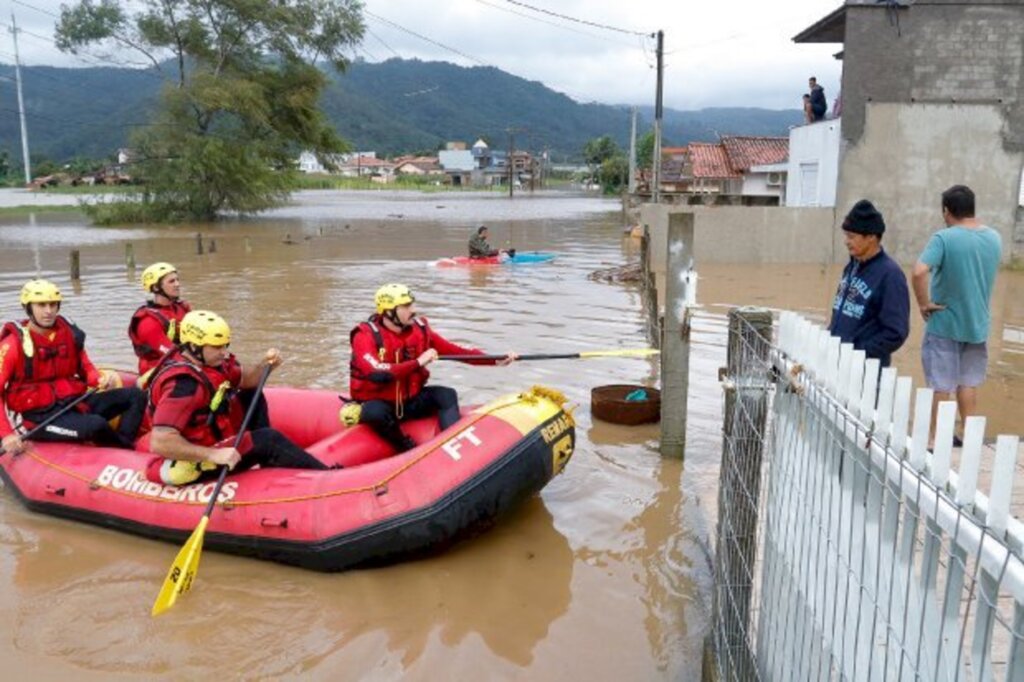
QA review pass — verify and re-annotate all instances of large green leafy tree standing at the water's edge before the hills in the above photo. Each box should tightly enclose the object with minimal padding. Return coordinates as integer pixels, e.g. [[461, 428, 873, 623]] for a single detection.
[[56, 0, 365, 221]]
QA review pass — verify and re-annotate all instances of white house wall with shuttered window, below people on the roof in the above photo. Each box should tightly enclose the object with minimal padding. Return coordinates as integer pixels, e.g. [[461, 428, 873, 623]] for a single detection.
[[785, 119, 843, 207]]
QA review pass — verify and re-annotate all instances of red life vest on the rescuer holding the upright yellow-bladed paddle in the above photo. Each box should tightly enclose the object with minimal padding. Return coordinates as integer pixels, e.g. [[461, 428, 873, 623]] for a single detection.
[[148, 354, 244, 445]]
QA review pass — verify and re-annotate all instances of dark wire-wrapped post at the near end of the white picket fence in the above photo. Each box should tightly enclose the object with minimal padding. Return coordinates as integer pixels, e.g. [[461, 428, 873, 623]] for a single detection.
[[713, 307, 772, 680]]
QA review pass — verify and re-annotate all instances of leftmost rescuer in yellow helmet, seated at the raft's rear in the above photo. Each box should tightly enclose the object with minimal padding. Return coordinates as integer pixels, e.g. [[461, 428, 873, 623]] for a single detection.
[[0, 280, 145, 454]]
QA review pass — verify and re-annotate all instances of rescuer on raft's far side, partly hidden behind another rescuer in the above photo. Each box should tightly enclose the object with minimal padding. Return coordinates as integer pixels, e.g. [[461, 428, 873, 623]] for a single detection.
[[128, 263, 191, 375]]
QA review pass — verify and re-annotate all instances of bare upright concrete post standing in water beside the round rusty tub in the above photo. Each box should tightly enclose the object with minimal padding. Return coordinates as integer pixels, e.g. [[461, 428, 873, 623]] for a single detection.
[[660, 213, 693, 459]]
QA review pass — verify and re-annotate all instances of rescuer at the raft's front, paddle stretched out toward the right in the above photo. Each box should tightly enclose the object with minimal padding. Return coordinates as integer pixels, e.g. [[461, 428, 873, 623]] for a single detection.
[[342, 284, 518, 453]]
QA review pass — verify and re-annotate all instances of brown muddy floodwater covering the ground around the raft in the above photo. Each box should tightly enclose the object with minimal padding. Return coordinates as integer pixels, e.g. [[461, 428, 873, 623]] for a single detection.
[[0, 191, 1024, 681]]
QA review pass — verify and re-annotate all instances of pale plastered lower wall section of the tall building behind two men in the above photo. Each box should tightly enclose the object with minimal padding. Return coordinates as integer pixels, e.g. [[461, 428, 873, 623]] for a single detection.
[[835, 102, 1024, 263]]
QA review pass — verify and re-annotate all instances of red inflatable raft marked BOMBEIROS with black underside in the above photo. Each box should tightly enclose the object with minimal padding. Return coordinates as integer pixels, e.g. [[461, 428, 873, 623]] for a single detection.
[[0, 387, 575, 571]]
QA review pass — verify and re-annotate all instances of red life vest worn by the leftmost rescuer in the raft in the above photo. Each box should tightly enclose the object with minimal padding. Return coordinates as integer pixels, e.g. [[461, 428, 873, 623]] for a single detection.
[[0, 315, 86, 413]]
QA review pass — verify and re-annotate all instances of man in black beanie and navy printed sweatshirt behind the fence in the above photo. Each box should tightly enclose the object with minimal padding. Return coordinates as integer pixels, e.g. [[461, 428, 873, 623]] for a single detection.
[[828, 199, 910, 367]]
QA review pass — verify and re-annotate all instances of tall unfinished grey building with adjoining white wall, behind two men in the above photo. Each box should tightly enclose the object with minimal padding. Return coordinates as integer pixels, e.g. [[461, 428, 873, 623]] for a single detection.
[[787, 0, 1024, 262]]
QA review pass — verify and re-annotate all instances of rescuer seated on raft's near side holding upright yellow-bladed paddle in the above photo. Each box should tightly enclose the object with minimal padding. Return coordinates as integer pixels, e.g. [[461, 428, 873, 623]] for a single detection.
[[139, 310, 329, 485]]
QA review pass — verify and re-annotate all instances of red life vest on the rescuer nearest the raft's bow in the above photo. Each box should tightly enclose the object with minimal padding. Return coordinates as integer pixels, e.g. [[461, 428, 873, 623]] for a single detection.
[[348, 315, 430, 406]]
